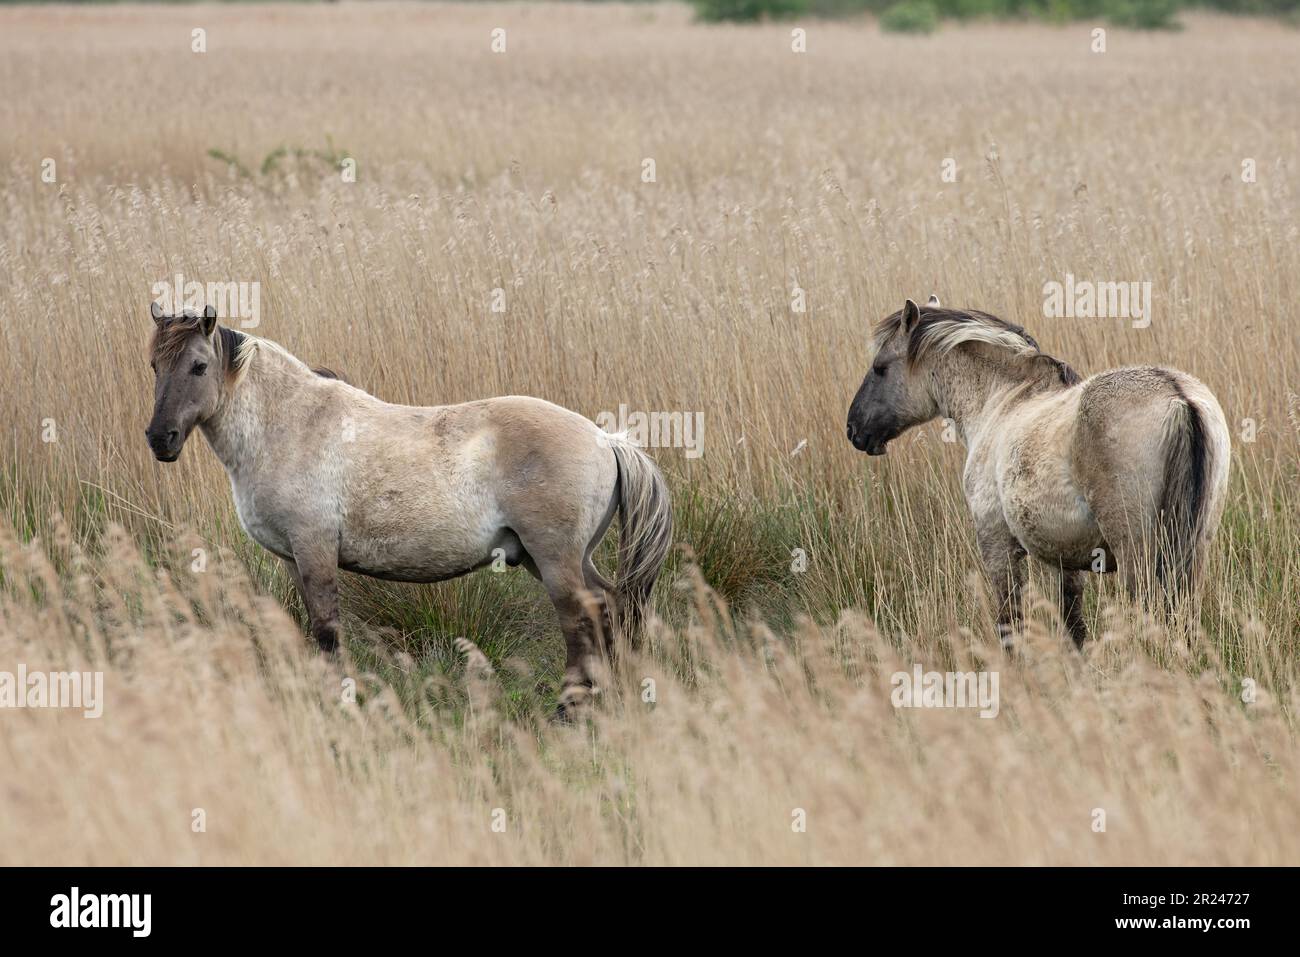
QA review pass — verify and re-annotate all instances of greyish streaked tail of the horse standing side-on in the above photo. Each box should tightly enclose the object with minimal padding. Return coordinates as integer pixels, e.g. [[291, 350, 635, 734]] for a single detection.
[[610, 436, 672, 637]]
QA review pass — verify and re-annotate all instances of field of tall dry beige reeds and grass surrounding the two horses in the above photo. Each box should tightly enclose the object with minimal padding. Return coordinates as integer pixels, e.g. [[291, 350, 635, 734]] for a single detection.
[[0, 3, 1300, 865]]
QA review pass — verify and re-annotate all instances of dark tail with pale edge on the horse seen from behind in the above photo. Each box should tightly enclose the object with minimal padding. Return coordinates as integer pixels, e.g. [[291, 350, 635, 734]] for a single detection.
[[1156, 376, 1231, 596]]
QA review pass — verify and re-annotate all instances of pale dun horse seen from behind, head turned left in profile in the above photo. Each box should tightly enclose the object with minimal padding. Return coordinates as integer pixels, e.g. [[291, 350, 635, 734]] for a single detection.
[[848, 296, 1231, 646]]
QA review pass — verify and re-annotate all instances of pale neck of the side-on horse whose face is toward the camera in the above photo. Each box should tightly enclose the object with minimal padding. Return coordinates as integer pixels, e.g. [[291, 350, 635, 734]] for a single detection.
[[200, 343, 312, 476]]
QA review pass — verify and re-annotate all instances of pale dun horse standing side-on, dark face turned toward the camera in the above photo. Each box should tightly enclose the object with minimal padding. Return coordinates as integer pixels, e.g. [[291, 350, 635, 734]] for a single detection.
[[146, 303, 672, 714]]
